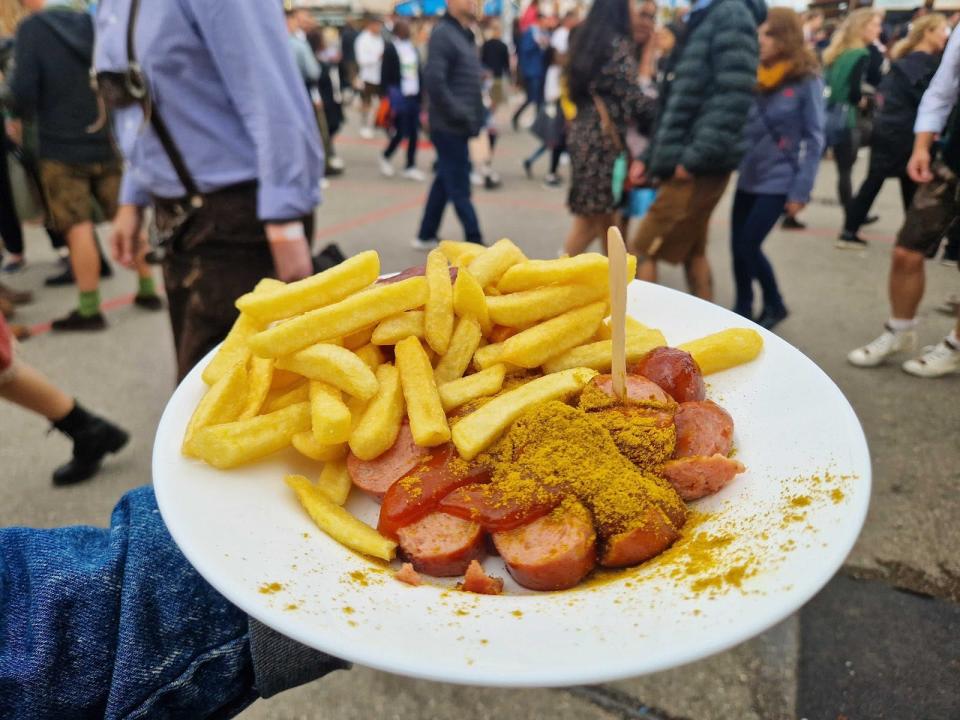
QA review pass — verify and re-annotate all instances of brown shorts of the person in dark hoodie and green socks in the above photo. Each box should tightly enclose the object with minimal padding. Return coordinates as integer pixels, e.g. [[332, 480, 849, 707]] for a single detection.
[[40, 160, 123, 232]]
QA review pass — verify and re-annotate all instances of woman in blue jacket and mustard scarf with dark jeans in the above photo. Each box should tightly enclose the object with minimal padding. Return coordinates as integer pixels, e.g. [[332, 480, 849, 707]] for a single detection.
[[731, 8, 824, 328]]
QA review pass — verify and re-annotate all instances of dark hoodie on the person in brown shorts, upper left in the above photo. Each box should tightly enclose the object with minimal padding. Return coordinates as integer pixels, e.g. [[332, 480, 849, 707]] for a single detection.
[[10, 7, 116, 164]]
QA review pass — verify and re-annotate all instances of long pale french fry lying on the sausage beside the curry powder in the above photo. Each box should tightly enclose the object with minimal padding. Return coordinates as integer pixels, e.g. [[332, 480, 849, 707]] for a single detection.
[[452, 366, 599, 460]]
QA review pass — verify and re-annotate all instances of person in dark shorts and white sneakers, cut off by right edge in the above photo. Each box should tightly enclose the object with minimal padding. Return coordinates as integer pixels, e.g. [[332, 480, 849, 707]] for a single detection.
[[847, 21, 960, 377]]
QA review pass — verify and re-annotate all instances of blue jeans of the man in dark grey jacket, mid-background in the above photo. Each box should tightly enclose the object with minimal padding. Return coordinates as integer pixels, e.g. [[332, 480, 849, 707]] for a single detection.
[[417, 130, 483, 245]]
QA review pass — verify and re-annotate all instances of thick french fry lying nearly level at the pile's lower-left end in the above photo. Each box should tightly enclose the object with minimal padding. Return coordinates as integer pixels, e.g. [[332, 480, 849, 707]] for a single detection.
[[192, 403, 310, 470]]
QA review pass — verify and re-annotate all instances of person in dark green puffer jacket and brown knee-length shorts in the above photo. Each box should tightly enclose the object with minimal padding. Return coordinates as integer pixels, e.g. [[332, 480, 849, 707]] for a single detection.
[[630, 0, 767, 300]]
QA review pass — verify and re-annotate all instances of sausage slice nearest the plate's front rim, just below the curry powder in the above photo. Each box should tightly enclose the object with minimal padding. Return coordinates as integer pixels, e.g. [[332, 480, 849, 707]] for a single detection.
[[493, 501, 597, 590]]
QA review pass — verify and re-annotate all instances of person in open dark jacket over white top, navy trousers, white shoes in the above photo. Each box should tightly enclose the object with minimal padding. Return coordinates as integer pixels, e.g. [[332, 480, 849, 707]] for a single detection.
[[380, 20, 426, 182]]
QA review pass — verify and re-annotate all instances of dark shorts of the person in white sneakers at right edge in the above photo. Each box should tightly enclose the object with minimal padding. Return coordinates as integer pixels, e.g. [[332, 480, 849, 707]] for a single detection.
[[897, 161, 960, 268]]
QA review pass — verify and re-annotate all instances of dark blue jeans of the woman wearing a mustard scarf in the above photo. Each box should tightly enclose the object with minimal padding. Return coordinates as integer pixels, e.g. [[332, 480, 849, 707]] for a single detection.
[[730, 190, 787, 317]]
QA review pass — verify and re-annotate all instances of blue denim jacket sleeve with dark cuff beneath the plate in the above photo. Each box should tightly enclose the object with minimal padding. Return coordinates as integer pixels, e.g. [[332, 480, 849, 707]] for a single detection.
[[0, 487, 345, 720]]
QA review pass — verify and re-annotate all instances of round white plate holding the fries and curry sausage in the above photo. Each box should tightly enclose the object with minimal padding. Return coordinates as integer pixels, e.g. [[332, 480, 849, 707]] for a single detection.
[[153, 282, 870, 686]]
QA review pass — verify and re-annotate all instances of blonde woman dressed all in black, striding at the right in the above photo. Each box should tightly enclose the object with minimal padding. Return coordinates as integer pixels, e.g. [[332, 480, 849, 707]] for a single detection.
[[838, 13, 950, 246]]
